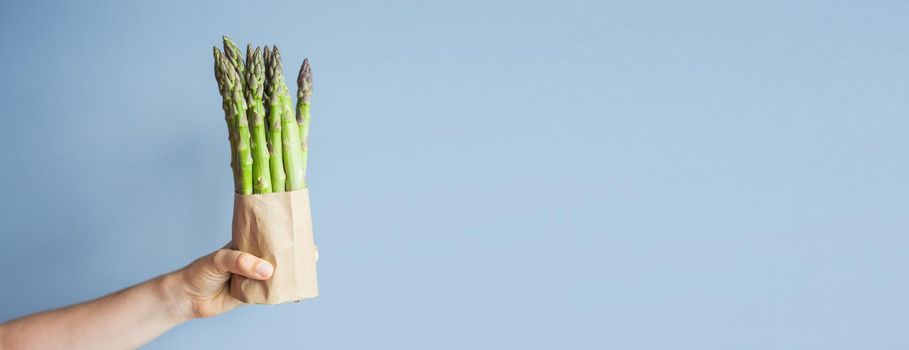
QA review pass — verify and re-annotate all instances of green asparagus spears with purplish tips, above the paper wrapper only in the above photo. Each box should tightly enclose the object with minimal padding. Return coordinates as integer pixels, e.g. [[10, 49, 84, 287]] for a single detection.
[[213, 36, 312, 195]]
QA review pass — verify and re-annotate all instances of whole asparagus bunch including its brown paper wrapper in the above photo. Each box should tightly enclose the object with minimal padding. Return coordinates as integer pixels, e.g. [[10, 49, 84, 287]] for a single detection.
[[213, 36, 319, 304]]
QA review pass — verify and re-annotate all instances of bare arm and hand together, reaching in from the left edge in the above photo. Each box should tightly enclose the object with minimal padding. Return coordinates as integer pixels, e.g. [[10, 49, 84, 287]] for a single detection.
[[0, 249, 274, 350]]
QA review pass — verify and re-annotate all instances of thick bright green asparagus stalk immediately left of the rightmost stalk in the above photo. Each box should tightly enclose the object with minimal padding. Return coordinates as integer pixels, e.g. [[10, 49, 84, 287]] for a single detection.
[[272, 46, 306, 191]]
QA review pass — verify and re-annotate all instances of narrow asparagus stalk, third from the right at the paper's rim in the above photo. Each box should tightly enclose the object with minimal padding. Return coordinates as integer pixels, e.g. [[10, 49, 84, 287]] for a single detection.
[[264, 46, 287, 192]]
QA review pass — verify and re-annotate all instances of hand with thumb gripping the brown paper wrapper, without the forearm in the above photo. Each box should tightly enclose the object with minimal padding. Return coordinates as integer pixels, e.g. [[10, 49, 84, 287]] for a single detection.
[[165, 249, 274, 319]]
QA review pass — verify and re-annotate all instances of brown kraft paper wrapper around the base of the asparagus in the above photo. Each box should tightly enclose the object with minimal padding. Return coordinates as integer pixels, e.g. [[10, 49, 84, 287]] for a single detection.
[[230, 189, 319, 304]]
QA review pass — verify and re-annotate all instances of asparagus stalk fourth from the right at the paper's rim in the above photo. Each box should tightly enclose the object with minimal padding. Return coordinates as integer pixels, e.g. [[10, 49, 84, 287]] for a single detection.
[[246, 45, 272, 193]]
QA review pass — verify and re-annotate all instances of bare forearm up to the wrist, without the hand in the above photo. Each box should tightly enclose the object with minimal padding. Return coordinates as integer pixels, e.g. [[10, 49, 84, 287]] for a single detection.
[[0, 273, 191, 349]]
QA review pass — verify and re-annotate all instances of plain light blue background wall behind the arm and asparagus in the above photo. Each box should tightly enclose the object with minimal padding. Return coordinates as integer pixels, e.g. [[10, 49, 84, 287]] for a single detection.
[[0, 0, 909, 349]]
